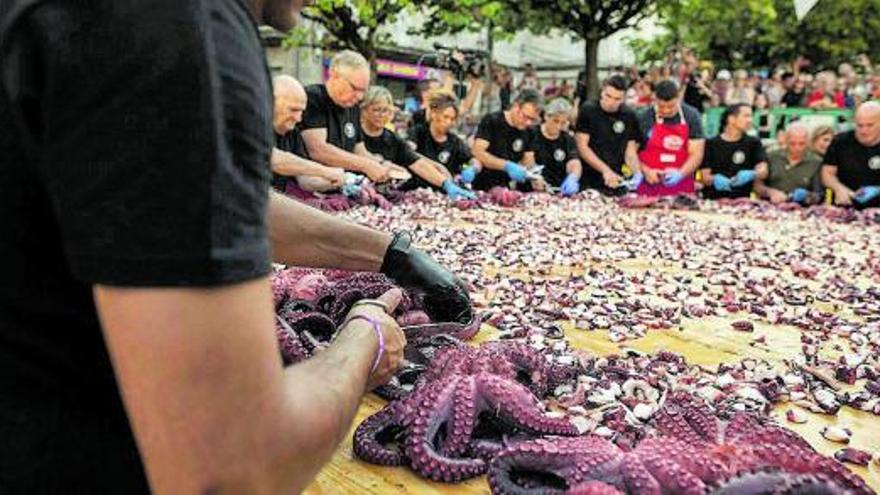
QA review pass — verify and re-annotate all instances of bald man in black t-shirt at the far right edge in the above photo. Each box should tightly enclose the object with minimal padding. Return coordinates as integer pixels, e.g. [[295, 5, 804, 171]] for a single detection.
[[822, 101, 880, 208]]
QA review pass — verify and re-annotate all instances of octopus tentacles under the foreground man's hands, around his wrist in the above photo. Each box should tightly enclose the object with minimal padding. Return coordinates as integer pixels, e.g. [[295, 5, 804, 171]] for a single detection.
[[272, 268, 480, 400]]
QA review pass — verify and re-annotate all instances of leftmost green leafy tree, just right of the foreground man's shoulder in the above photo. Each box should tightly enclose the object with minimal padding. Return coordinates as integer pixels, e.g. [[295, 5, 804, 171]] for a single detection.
[[303, 0, 414, 64]]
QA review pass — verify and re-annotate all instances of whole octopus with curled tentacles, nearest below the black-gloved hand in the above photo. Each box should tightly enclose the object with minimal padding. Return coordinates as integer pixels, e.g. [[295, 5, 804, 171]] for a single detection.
[[353, 342, 578, 482]]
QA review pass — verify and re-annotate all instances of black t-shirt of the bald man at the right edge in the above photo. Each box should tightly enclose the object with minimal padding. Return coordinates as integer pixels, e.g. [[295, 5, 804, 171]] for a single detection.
[[822, 131, 880, 208]]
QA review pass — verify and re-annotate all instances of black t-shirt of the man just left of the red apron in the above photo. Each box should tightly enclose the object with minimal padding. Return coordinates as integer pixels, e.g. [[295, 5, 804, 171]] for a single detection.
[[574, 102, 639, 187]]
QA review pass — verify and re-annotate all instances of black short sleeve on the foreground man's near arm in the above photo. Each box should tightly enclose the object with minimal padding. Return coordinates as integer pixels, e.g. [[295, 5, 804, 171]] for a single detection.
[[8, 2, 272, 286]]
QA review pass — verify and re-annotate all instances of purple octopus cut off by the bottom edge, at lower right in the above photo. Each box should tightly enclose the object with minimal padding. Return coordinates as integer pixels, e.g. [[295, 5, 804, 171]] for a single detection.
[[489, 392, 873, 495]]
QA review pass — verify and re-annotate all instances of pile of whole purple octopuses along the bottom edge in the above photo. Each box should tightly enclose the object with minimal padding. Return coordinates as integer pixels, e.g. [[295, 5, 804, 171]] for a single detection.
[[353, 341, 873, 495]]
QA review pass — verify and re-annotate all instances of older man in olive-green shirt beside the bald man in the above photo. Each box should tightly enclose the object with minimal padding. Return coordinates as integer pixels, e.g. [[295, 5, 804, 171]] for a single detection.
[[755, 123, 822, 204]]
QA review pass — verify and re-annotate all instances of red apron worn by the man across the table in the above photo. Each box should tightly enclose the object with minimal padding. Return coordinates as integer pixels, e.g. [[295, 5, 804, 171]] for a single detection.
[[636, 110, 695, 196]]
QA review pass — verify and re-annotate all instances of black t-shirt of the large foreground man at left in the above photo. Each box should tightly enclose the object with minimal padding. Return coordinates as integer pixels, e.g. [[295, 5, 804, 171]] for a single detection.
[[0, 0, 272, 494]]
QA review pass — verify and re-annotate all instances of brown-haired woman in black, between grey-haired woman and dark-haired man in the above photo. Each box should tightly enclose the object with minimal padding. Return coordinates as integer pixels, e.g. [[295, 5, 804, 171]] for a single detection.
[[404, 91, 473, 189]]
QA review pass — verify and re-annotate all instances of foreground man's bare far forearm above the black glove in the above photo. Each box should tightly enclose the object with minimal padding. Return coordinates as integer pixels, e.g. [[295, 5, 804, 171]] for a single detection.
[[268, 192, 391, 271]]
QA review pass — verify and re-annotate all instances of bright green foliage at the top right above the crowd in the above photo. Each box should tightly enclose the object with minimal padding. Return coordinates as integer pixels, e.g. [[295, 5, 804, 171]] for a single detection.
[[633, 0, 880, 69]]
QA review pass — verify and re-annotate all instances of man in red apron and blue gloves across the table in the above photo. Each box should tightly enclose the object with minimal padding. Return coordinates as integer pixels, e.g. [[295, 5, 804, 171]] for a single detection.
[[637, 80, 706, 196]]
